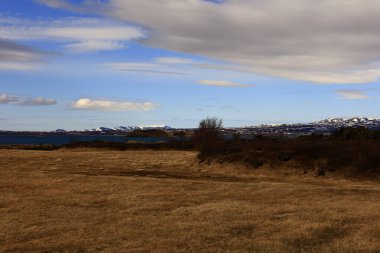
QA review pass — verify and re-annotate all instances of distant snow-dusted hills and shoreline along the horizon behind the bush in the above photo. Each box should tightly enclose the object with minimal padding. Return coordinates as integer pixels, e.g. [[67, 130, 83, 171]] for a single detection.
[[0, 117, 380, 138]]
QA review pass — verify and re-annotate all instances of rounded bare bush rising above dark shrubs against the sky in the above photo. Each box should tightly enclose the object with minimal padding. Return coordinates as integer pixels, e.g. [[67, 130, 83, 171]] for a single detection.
[[195, 117, 223, 153]]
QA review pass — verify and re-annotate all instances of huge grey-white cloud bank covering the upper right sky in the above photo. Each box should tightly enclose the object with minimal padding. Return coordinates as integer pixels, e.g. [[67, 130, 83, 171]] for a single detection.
[[37, 0, 380, 84]]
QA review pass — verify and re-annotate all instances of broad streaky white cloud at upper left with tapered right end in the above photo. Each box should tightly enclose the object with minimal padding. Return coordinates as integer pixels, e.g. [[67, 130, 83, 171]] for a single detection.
[[0, 18, 145, 52]]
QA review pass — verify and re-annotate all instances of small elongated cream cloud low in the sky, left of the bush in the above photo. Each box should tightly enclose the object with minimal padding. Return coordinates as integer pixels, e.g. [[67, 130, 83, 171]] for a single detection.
[[71, 98, 158, 111]]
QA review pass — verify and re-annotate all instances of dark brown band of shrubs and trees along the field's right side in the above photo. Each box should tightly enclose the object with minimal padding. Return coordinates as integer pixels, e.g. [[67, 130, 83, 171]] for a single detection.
[[196, 121, 380, 177]]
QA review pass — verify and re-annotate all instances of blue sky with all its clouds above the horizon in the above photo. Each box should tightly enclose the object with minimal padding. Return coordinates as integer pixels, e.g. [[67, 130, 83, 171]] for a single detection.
[[0, 0, 380, 131]]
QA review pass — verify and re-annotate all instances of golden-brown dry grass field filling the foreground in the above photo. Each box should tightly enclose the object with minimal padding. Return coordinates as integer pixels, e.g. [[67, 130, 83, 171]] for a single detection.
[[0, 149, 380, 252]]
